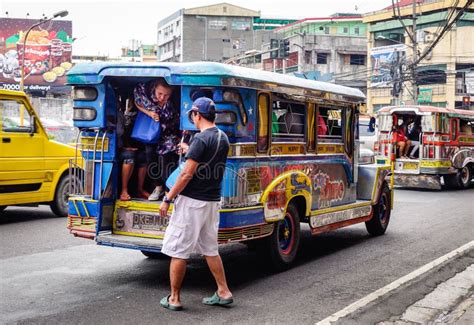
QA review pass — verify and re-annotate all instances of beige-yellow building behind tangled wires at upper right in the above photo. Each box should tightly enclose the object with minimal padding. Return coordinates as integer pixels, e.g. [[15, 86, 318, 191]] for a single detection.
[[364, 0, 474, 111]]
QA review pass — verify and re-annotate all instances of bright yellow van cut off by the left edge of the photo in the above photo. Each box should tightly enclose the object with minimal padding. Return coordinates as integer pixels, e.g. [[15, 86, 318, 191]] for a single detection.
[[0, 89, 78, 216]]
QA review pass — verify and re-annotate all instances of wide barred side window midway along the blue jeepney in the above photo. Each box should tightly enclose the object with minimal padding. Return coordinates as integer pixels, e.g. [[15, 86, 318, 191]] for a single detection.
[[272, 99, 305, 142]]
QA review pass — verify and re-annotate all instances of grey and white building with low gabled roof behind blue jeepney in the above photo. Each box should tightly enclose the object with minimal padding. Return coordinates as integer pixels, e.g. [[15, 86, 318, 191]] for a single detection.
[[157, 3, 260, 62]]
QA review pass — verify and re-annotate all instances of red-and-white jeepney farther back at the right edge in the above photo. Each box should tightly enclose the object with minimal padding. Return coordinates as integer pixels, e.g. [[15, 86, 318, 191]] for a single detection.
[[376, 106, 474, 189]]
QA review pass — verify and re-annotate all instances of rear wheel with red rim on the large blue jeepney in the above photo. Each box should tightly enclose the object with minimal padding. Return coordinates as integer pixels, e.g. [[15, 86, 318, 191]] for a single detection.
[[260, 203, 301, 272]]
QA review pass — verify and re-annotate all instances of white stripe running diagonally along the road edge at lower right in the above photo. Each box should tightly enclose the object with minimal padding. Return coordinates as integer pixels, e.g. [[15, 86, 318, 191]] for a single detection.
[[316, 241, 474, 325]]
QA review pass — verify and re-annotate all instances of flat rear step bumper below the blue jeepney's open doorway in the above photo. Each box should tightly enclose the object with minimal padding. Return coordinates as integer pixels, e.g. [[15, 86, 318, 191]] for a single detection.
[[96, 233, 163, 252]]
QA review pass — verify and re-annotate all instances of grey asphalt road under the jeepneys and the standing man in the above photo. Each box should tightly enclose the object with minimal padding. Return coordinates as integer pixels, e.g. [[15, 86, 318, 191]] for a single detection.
[[0, 188, 474, 324]]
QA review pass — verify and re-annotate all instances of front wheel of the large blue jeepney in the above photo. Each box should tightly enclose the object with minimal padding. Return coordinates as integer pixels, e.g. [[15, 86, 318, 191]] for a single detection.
[[365, 183, 391, 236]]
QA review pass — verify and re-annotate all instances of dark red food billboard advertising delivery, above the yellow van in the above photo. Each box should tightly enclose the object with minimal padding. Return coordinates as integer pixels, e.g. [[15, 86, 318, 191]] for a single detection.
[[0, 18, 73, 93]]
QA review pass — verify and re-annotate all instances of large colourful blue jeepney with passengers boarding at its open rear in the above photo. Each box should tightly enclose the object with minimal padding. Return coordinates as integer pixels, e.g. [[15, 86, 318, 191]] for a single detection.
[[68, 62, 392, 269]]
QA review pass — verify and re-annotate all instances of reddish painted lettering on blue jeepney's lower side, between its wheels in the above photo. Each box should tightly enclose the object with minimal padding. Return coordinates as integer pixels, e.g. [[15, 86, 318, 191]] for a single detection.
[[313, 171, 345, 208]]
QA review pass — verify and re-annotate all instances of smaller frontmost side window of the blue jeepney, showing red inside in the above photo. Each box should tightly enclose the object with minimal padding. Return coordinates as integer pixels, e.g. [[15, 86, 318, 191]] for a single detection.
[[318, 105, 342, 142]]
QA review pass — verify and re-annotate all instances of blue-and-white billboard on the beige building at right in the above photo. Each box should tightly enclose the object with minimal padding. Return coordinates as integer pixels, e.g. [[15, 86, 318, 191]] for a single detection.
[[370, 44, 406, 87]]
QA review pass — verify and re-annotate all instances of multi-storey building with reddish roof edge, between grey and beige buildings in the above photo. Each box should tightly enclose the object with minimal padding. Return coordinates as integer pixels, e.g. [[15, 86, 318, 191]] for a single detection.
[[262, 13, 367, 91]]
